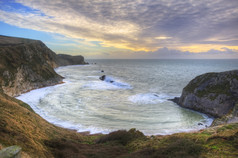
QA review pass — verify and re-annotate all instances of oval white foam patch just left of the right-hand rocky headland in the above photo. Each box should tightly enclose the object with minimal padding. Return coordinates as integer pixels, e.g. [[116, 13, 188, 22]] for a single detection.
[[128, 93, 171, 104]]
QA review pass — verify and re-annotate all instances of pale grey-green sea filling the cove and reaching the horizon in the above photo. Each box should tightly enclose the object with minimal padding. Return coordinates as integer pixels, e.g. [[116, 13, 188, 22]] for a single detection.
[[17, 60, 238, 135]]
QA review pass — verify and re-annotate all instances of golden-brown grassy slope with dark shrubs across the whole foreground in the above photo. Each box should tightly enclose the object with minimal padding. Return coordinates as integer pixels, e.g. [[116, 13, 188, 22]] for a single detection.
[[0, 93, 238, 158]]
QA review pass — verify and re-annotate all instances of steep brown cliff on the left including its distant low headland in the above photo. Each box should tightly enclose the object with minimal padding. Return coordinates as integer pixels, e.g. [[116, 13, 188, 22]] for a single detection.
[[0, 36, 85, 96]]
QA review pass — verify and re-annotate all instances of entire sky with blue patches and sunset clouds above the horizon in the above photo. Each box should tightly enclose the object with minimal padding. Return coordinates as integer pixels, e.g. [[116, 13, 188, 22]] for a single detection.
[[0, 0, 238, 59]]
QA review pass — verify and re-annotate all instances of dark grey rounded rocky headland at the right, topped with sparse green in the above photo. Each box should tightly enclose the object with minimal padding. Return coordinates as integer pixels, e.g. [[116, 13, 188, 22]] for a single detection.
[[176, 70, 238, 117]]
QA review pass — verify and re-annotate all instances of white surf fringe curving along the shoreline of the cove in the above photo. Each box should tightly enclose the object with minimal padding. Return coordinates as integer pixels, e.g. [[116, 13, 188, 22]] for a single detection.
[[16, 65, 213, 136]]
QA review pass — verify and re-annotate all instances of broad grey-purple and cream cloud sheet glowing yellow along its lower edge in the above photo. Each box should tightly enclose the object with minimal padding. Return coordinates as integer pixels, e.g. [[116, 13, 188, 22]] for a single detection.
[[0, 0, 238, 53]]
